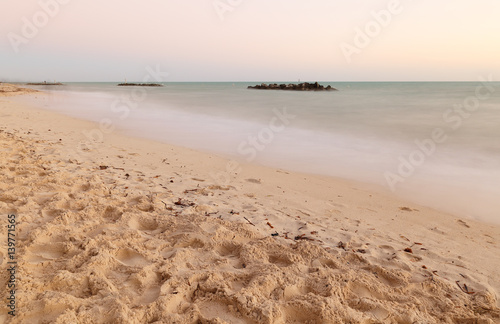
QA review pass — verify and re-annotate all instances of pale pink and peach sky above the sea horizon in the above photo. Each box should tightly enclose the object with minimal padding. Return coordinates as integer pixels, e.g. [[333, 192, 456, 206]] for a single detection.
[[0, 0, 500, 82]]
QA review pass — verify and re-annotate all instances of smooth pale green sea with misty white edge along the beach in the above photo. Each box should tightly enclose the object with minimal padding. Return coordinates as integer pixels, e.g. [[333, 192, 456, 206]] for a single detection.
[[15, 81, 500, 223]]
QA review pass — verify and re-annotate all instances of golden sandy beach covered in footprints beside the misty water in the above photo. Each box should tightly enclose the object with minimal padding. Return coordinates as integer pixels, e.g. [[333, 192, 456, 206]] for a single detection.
[[0, 85, 500, 323]]
